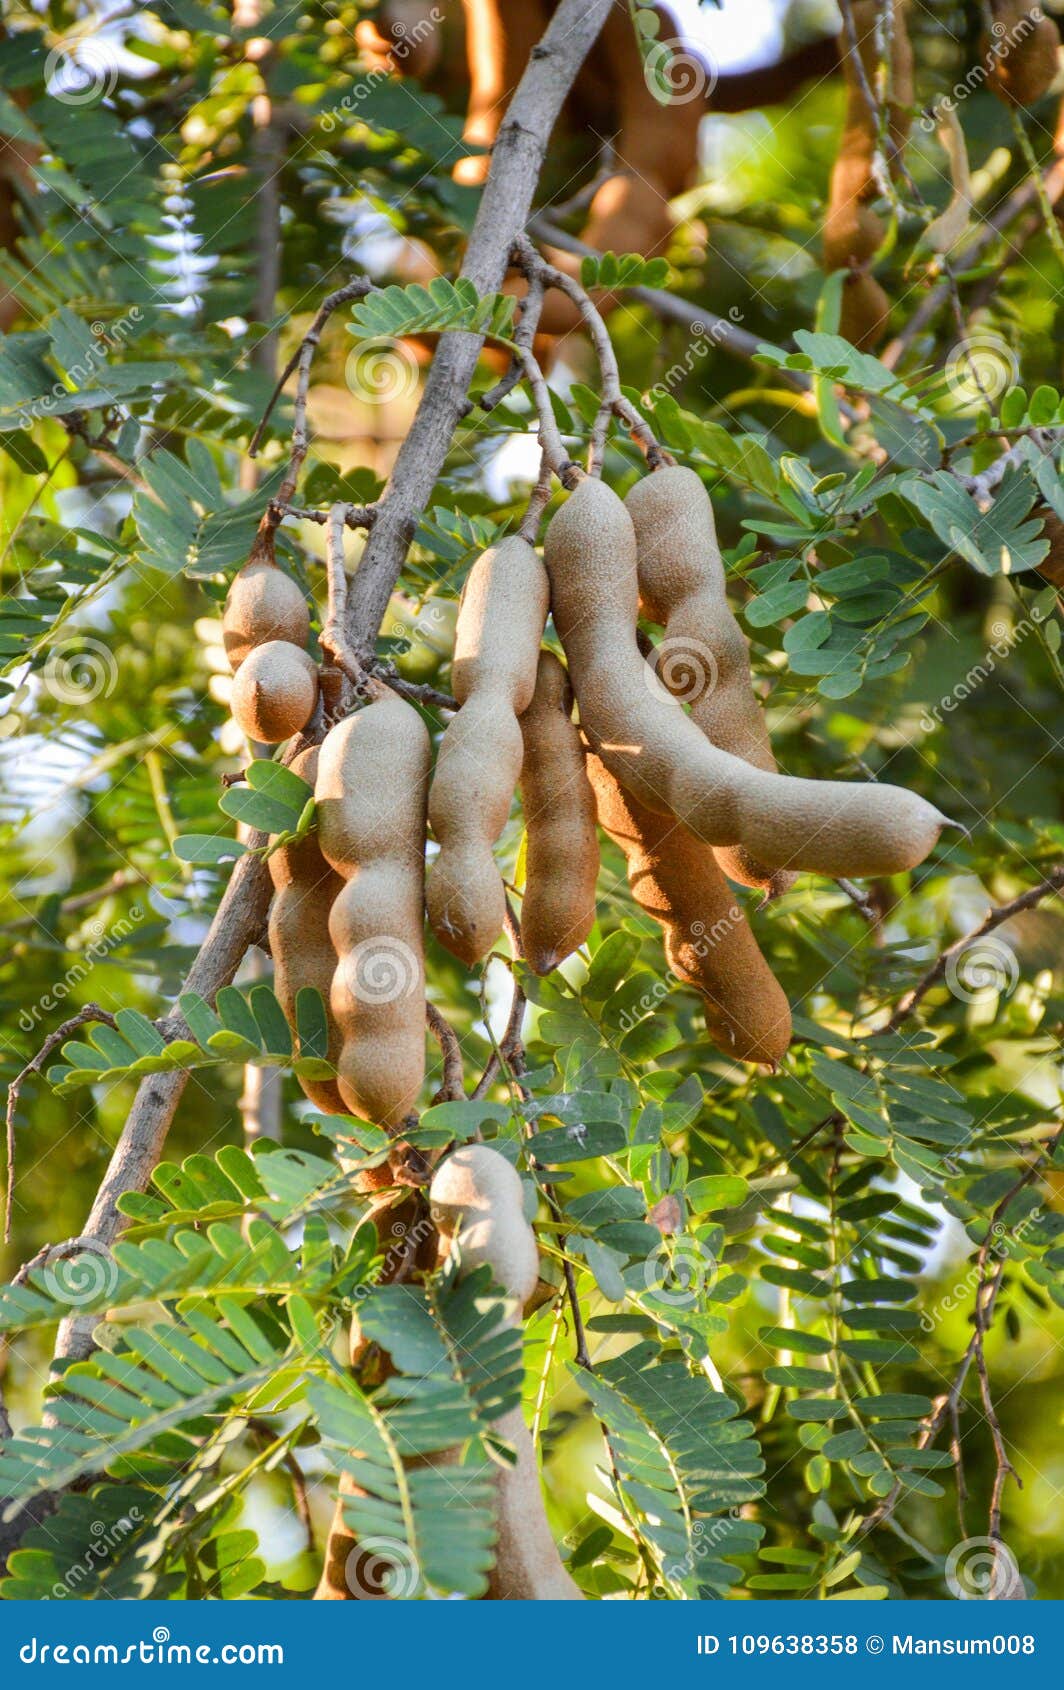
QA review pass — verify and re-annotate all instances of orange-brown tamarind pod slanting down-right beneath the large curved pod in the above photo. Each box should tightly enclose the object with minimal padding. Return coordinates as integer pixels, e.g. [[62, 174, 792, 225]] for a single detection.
[[588, 757, 790, 1068]]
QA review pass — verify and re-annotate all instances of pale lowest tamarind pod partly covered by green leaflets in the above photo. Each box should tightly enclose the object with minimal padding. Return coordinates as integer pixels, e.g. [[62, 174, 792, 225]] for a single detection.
[[429, 1144, 584, 1602]]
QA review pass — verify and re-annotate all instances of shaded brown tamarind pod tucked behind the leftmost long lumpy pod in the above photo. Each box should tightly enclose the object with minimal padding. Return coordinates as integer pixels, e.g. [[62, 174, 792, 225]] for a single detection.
[[267, 745, 346, 1115]]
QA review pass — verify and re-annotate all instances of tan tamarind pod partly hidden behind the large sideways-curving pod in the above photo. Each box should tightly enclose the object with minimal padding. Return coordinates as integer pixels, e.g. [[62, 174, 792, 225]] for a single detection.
[[625, 465, 794, 897]]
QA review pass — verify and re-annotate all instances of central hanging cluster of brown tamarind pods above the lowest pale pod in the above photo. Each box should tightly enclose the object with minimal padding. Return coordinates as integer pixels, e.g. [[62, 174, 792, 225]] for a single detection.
[[225, 463, 946, 1134]]
